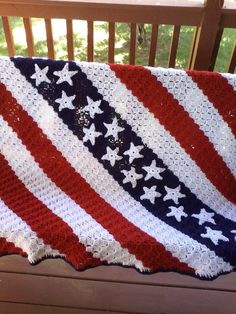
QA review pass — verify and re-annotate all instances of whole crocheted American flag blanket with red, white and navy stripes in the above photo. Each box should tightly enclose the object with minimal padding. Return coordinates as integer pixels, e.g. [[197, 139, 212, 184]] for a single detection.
[[0, 58, 236, 279]]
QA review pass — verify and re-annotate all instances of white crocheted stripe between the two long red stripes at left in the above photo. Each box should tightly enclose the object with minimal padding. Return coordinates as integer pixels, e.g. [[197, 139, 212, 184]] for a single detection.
[[0, 116, 144, 270]]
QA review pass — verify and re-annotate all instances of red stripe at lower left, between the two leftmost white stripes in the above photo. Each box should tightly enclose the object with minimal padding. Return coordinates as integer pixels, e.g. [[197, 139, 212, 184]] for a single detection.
[[0, 154, 101, 269]]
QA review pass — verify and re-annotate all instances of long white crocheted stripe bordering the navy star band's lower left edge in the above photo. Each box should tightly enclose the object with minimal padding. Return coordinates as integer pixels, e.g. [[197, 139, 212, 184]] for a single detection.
[[0, 61, 232, 276]]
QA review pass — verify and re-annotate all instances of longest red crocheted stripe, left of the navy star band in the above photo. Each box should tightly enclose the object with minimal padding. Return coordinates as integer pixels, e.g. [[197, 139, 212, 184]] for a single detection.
[[0, 85, 194, 272]]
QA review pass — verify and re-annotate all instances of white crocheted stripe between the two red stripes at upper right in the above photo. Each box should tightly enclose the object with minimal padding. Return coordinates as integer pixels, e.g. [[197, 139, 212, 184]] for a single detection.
[[147, 67, 236, 176]]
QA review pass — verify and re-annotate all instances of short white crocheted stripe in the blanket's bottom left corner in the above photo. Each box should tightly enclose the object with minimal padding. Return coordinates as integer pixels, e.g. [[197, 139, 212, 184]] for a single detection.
[[0, 199, 60, 263]]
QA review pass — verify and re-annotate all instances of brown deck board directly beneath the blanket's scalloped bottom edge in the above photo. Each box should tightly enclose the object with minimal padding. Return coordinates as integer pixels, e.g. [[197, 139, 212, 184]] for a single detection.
[[0, 255, 236, 292]]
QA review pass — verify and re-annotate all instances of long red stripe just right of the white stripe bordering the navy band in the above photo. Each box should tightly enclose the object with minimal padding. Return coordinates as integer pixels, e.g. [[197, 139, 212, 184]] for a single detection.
[[110, 65, 236, 204]]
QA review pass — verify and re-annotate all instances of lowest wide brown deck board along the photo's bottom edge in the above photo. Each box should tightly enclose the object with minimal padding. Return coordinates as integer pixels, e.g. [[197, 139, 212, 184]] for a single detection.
[[0, 272, 236, 314]]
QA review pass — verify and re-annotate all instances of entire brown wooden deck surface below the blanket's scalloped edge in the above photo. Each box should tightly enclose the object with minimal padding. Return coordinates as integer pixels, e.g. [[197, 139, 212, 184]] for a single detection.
[[0, 256, 236, 314]]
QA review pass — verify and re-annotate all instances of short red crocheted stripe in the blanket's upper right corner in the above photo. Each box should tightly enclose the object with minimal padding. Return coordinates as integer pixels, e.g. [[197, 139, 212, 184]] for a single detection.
[[187, 71, 236, 137]]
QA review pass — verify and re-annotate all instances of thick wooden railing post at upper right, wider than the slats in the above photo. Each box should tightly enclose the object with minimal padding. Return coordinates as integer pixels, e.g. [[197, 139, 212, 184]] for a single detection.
[[190, 0, 224, 70]]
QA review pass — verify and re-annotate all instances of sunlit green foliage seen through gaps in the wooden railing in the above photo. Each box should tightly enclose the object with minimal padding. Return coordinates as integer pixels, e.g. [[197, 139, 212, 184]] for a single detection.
[[0, 17, 236, 72]]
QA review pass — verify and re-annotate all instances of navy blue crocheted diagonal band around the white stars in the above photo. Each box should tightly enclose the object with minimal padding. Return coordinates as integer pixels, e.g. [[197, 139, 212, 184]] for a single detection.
[[12, 58, 236, 266]]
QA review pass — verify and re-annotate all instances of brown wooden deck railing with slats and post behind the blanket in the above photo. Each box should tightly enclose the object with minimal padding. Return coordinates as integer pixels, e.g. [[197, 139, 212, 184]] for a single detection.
[[0, 0, 236, 73]]
